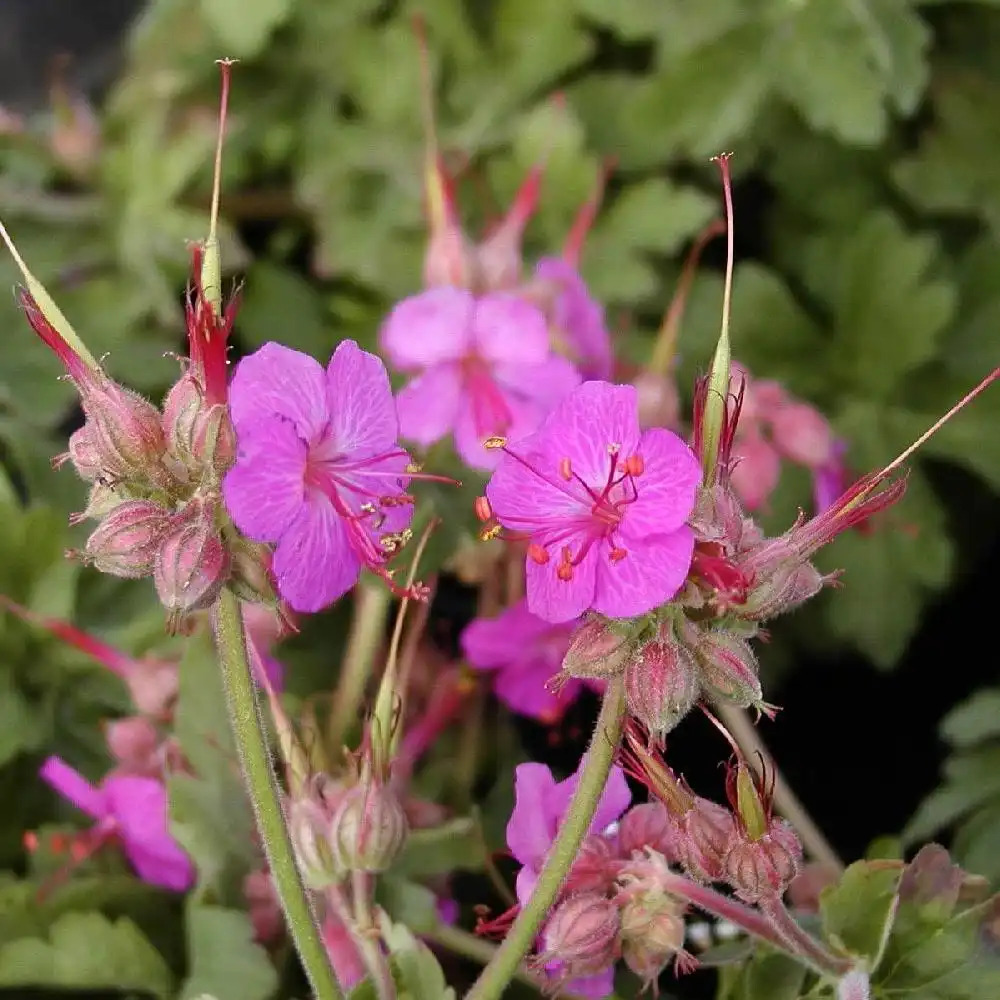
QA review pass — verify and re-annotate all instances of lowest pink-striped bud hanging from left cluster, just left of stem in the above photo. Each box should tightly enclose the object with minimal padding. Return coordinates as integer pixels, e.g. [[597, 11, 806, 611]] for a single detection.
[[153, 499, 229, 617]]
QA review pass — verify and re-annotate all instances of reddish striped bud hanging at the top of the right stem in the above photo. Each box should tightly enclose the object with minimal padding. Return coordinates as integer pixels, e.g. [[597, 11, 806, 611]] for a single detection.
[[625, 630, 700, 739]]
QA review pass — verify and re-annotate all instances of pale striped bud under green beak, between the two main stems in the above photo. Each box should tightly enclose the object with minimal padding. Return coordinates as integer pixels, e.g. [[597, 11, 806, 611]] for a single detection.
[[330, 782, 409, 872]]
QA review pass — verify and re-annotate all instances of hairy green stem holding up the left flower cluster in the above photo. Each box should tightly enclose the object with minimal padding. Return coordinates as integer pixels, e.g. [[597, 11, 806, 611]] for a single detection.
[[215, 590, 343, 1000]]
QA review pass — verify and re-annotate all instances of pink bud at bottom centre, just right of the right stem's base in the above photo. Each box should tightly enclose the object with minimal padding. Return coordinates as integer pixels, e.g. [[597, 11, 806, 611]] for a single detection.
[[538, 892, 621, 979]]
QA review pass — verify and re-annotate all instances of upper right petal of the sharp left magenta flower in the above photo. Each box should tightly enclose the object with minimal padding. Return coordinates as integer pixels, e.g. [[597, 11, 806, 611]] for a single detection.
[[326, 340, 399, 457]]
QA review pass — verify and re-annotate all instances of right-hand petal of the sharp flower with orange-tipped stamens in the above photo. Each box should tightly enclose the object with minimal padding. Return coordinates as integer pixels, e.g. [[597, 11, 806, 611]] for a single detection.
[[622, 427, 701, 544]]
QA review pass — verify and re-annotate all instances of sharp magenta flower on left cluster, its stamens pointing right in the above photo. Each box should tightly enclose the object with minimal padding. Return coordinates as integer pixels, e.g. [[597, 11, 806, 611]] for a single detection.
[[223, 340, 412, 611]]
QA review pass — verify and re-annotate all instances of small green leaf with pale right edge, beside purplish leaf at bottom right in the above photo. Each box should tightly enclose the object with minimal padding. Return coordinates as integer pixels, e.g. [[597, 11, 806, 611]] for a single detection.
[[819, 861, 902, 970]]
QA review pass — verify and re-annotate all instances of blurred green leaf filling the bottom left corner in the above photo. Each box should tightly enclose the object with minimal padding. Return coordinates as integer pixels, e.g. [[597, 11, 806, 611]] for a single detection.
[[0, 913, 172, 1000]]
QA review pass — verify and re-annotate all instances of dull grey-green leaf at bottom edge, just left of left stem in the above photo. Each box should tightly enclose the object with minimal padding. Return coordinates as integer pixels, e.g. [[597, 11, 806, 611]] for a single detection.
[[180, 901, 278, 1000]]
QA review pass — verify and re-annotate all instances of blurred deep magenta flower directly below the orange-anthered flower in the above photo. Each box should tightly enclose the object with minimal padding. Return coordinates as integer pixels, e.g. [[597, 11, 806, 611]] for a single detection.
[[462, 601, 580, 722]]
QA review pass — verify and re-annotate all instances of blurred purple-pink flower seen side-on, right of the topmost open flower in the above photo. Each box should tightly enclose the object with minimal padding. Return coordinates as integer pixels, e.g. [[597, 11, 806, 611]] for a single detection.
[[535, 257, 614, 378]]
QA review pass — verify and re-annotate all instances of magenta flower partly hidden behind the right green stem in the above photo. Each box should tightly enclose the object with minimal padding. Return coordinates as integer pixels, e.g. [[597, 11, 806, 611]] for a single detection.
[[507, 763, 632, 906]]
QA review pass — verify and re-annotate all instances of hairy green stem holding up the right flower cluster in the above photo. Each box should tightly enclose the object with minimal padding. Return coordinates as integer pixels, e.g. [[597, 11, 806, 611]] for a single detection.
[[465, 677, 625, 1000]]
